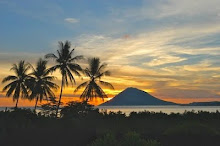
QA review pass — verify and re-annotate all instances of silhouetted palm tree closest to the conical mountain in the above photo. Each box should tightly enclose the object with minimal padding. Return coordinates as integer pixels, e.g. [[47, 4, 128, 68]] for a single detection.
[[74, 58, 114, 102]]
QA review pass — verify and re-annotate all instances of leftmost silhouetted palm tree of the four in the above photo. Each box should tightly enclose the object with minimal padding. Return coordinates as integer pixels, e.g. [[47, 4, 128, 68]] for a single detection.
[[2, 60, 30, 108]]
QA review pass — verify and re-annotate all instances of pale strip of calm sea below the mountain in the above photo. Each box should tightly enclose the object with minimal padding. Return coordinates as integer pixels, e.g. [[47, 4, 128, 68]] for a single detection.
[[0, 105, 220, 115]]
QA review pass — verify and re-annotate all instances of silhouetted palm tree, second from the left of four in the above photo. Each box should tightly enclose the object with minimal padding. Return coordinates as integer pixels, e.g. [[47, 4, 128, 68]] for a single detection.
[[27, 58, 58, 110]]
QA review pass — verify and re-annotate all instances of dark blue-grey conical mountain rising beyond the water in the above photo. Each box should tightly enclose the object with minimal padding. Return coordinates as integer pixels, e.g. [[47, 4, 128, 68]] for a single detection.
[[101, 87, 176, 106]]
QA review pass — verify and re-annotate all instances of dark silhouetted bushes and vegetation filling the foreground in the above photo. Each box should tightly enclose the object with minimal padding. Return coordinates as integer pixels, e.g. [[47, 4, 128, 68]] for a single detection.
[[0, 100, 220, 146]]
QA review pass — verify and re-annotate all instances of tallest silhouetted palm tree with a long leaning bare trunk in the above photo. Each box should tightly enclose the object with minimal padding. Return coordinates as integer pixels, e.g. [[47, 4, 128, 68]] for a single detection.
[[45, 41, 83, 116]]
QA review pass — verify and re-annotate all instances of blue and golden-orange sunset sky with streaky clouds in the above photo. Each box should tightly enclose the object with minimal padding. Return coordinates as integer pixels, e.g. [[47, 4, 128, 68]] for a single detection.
[[0, 0, 220, 106]]
